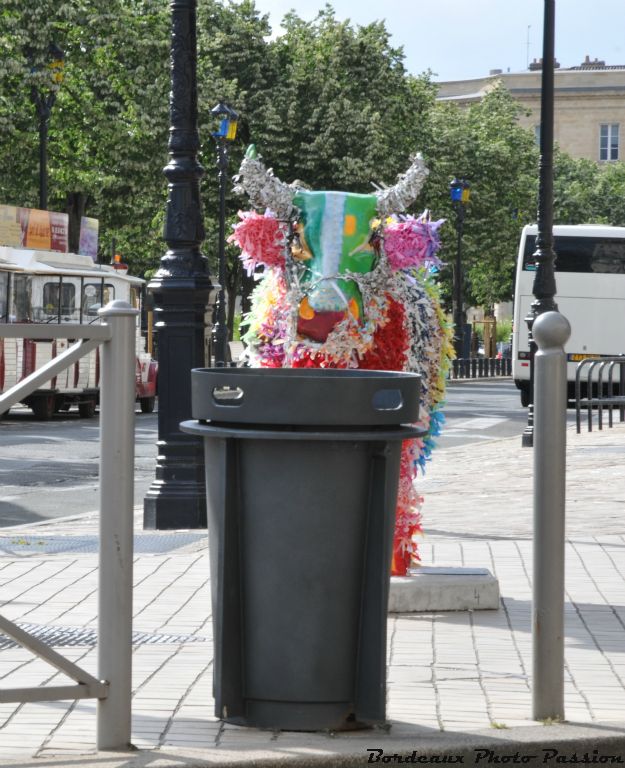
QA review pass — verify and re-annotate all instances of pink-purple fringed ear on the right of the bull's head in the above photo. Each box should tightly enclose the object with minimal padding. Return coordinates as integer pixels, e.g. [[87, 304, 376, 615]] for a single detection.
[[384, 216, 444, 270]]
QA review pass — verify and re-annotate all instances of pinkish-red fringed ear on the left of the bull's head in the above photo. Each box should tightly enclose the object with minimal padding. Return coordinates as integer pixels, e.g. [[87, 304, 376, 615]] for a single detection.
[[228, 211, 287, 275]]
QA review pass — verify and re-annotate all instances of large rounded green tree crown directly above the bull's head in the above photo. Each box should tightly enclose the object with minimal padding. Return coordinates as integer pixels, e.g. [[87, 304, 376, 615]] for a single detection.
[[262, 5, 434, 192]]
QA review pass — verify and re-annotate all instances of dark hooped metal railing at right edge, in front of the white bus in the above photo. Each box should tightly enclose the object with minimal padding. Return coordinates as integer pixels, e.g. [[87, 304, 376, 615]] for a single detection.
[[575, 355, 625, 434]]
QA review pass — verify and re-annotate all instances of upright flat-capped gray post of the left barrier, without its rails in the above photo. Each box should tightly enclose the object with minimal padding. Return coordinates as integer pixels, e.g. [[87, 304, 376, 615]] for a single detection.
[[97, 300, 138, 750]]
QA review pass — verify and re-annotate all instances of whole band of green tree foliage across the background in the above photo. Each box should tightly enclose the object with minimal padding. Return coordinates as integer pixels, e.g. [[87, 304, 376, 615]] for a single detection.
[[0, 0, 625, 316]]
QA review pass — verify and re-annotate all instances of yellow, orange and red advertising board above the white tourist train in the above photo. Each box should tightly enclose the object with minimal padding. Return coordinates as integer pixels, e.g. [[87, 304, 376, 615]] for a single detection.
[[0, 205, 69, 253]]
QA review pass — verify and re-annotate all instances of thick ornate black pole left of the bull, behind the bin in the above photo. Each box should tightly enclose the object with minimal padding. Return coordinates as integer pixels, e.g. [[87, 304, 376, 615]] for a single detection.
[[143, 0, 212, 529]]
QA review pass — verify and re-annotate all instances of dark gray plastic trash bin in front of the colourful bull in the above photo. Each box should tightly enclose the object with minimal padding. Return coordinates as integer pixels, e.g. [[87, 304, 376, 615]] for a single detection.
[[181, 368, 423, 730]]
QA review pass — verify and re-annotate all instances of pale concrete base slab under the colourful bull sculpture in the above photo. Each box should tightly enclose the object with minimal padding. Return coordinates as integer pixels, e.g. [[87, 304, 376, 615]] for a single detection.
[[388, 566, 499, 613]]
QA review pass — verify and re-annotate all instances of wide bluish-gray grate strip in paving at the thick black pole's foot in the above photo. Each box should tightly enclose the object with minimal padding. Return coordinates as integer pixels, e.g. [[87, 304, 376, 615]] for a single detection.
[[0, 531, 208, 555]]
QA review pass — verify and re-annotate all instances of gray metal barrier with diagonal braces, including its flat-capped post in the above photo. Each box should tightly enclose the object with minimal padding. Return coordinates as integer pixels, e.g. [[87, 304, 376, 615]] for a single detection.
[[0, 301, 138, 750]]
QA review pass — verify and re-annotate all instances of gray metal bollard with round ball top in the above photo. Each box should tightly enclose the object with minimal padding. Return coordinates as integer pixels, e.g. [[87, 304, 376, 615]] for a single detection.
[[532, 312, 571, 720]]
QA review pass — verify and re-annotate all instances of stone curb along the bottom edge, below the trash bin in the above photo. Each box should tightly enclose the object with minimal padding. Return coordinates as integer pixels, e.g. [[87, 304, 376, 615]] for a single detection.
[[0, 723, 625, 768]]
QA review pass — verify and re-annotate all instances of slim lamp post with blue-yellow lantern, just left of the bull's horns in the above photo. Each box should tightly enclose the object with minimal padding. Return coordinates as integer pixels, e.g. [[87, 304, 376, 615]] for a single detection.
[[211, 101, 239, 367]]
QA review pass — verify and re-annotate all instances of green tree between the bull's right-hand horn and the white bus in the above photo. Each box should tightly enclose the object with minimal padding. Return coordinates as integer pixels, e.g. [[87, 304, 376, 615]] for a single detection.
[[426, 88, 538, 309]]
